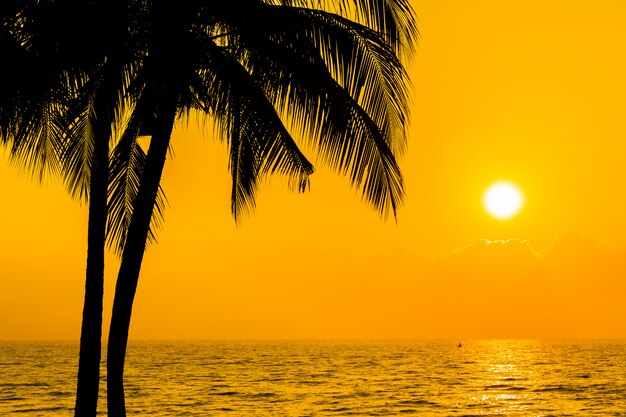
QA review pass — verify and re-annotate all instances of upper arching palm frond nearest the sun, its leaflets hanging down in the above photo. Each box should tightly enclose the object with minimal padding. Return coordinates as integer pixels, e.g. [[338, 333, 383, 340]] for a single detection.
[[272, 5, 410, 155]]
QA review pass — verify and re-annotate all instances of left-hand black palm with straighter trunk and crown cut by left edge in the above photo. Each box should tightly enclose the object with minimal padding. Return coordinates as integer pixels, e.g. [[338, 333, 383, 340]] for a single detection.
[[0, 0, 152, 417]]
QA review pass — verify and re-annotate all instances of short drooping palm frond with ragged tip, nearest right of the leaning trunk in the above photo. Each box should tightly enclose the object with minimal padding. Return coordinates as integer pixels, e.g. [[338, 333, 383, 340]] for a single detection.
[[196, 43, 313, 219]]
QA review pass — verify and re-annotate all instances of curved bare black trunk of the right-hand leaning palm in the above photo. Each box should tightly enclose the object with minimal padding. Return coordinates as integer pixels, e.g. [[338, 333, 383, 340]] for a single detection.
[[107, 100, 176, 417]]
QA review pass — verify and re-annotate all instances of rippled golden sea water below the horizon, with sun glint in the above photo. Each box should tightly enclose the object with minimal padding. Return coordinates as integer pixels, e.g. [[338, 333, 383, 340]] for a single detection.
[[0, 340, 626, 417]]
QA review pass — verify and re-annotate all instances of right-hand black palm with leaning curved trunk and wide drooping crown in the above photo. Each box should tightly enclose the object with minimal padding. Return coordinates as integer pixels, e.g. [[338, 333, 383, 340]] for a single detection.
[[107, 0, 417, 417]]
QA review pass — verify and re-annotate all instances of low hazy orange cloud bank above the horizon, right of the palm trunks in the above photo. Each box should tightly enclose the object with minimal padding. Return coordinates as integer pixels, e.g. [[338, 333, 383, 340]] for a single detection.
[[91, 229, 626, 340]]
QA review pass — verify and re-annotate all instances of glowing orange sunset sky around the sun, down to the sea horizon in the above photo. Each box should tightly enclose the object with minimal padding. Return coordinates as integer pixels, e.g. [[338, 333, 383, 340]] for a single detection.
[[0, 0, 626, 339]]
